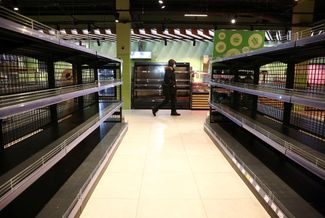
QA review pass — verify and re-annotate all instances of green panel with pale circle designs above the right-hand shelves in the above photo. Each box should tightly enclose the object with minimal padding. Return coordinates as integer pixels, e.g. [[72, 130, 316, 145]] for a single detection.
[[213, 30, 265, 58]]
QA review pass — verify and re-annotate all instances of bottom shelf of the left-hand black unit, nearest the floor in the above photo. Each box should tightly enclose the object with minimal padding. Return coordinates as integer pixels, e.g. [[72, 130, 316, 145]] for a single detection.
[[0, 122, 127, 217]]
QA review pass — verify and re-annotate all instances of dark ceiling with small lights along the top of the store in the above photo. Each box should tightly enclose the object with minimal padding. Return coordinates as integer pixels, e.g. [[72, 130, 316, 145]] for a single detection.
[[0, 0, 325, 29]]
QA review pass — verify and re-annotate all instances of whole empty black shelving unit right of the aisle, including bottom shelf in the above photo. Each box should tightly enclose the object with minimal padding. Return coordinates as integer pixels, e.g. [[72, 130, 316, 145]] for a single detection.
[[205, 31, 325, 217]]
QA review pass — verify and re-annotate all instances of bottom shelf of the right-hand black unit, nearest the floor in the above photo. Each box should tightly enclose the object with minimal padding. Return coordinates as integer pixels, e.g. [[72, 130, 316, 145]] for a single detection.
[[204, 121, 325, 217]]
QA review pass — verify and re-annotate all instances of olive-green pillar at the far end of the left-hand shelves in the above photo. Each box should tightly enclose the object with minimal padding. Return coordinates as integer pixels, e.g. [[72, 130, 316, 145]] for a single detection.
[[116, 0, 131, 109]]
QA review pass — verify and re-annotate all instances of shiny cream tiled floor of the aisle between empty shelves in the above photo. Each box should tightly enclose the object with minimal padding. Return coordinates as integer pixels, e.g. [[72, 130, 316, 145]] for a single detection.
[[81, 110, 269, 218]]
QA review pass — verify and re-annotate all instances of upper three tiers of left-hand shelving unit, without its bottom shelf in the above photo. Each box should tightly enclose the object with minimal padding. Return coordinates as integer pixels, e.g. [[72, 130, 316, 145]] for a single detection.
[[0, 8, 127, 213]]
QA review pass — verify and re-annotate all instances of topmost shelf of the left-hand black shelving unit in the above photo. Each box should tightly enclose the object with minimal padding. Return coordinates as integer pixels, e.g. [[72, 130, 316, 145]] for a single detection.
[[0, 17, 122, 67]]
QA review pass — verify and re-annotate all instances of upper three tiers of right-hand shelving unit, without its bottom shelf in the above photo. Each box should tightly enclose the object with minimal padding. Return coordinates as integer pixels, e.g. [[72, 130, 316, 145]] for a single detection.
[[210, 31, 325, 179]]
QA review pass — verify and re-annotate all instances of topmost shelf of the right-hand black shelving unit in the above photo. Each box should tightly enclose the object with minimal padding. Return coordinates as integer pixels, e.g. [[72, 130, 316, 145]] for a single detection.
[[212, 34, 325, 68]]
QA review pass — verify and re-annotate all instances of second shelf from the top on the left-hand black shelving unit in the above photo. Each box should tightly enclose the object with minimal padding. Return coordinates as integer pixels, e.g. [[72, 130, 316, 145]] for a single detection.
[[0, 80, 122, 119]]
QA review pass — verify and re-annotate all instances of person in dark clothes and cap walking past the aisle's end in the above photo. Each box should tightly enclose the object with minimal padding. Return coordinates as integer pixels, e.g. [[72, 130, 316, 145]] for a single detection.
[[152, 59, 180, 116]]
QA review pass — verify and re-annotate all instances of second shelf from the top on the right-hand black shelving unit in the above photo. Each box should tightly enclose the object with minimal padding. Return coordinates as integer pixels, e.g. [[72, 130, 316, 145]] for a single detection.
[[210, 82, 325, 109]]
